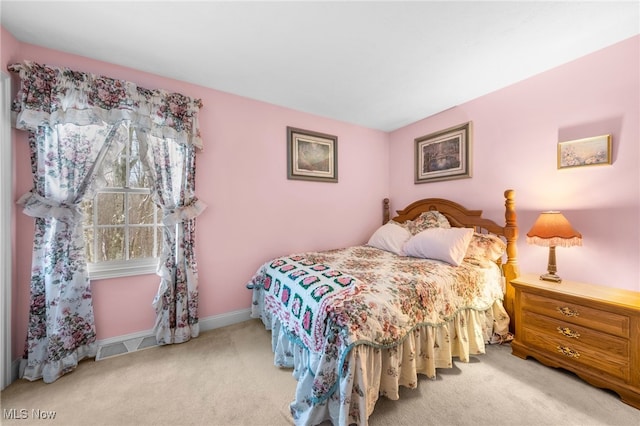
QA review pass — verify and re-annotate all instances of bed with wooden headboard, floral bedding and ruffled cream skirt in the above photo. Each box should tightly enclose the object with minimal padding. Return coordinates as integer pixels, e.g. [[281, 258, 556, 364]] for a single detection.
[[247, 190, 518, 425]]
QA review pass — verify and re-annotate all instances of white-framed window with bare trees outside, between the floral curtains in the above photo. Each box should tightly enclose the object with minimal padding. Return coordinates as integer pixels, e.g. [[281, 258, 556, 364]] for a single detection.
[[82, 123, 163, 279]]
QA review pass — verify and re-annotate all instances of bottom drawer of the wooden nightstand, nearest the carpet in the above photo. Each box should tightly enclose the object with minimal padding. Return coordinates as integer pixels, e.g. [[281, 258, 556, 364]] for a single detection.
[[522, 326, 630, 381]]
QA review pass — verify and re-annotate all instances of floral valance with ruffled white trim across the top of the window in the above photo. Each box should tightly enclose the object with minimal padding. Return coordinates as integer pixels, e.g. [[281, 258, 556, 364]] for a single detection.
[[8, 61, 203, 149]]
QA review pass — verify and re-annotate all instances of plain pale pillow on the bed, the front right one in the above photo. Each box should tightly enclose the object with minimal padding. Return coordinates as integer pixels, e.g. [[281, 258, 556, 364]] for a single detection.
[[403, 228, 473, 266]]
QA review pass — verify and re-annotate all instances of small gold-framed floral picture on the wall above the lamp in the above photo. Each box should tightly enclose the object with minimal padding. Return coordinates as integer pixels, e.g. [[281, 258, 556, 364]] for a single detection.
[[558, 135, 611, 169]]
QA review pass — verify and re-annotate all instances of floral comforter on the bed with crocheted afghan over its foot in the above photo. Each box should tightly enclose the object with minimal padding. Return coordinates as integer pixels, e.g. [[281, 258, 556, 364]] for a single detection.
[[247, 246, 503, 410]]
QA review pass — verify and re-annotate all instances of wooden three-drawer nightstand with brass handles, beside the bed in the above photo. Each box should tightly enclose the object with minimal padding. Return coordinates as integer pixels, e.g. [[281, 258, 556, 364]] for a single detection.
[[511, 275, 640, 409]]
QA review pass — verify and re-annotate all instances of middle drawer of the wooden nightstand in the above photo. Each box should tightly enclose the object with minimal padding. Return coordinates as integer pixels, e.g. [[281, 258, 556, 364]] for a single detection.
[[522, 311, 629, 361]]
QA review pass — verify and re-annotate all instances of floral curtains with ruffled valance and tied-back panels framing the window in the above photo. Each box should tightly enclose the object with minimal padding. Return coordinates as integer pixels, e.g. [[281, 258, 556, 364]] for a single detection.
[[9, 61, 204, 382]]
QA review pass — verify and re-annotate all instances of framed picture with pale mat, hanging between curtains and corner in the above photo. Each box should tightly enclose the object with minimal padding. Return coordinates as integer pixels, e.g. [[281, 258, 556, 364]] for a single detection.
[[287, 127, 338, 182]]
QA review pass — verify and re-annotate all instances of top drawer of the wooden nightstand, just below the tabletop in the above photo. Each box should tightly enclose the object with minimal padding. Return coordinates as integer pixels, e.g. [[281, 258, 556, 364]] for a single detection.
[[520, 293, 629, 338]]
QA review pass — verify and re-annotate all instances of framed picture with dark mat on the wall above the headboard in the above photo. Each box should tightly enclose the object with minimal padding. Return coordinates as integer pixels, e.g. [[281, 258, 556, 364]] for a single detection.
[[415, 122, 471, 183]]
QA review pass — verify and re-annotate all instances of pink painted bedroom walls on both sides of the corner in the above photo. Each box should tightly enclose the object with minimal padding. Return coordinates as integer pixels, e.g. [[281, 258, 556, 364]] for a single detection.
[[1, 29, 640, 357]]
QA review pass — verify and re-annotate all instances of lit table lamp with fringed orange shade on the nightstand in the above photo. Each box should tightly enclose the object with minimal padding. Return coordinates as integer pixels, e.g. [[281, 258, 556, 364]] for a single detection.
[[527, 211, 582, 283]]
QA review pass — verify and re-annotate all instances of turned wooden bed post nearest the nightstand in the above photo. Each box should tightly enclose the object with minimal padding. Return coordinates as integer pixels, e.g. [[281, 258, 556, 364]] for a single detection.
[[502, 189, 520, 332]]
